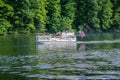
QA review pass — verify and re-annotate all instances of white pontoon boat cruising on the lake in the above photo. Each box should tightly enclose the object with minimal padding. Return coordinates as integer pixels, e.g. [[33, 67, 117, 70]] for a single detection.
[[36, 33, 76, 43]]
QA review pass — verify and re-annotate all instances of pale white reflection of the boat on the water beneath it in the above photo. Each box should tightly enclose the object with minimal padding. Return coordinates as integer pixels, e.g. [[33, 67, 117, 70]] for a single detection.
[[36, 42, 77, 53]]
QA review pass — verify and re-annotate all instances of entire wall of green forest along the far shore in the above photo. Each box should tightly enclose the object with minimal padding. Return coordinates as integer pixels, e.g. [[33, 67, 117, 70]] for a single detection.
[[0, 0, 120, 34]]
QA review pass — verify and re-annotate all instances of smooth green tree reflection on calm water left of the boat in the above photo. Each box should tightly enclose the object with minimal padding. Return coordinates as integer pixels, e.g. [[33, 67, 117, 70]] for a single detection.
[[0, 35, 35, 55]]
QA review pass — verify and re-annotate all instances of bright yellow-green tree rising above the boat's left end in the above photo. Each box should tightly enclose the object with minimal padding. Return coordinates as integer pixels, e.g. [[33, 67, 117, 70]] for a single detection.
[[30, 0, 47, 32]]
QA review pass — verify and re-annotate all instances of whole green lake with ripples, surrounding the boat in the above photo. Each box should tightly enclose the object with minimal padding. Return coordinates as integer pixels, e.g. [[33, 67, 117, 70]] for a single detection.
[[0, 33, 120, 80]]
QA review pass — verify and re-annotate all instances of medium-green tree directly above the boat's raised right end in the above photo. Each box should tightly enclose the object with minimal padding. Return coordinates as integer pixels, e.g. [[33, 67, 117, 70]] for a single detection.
[[60, 0, 76, 30]]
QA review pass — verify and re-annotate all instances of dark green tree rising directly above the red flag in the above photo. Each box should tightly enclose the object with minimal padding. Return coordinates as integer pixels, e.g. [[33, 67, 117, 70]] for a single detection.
[[75, 0, 99, 30]]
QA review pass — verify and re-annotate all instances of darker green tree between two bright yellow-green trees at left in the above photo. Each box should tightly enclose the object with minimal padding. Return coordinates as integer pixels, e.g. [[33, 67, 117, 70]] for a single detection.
[[7, 0, 35, 33]]
